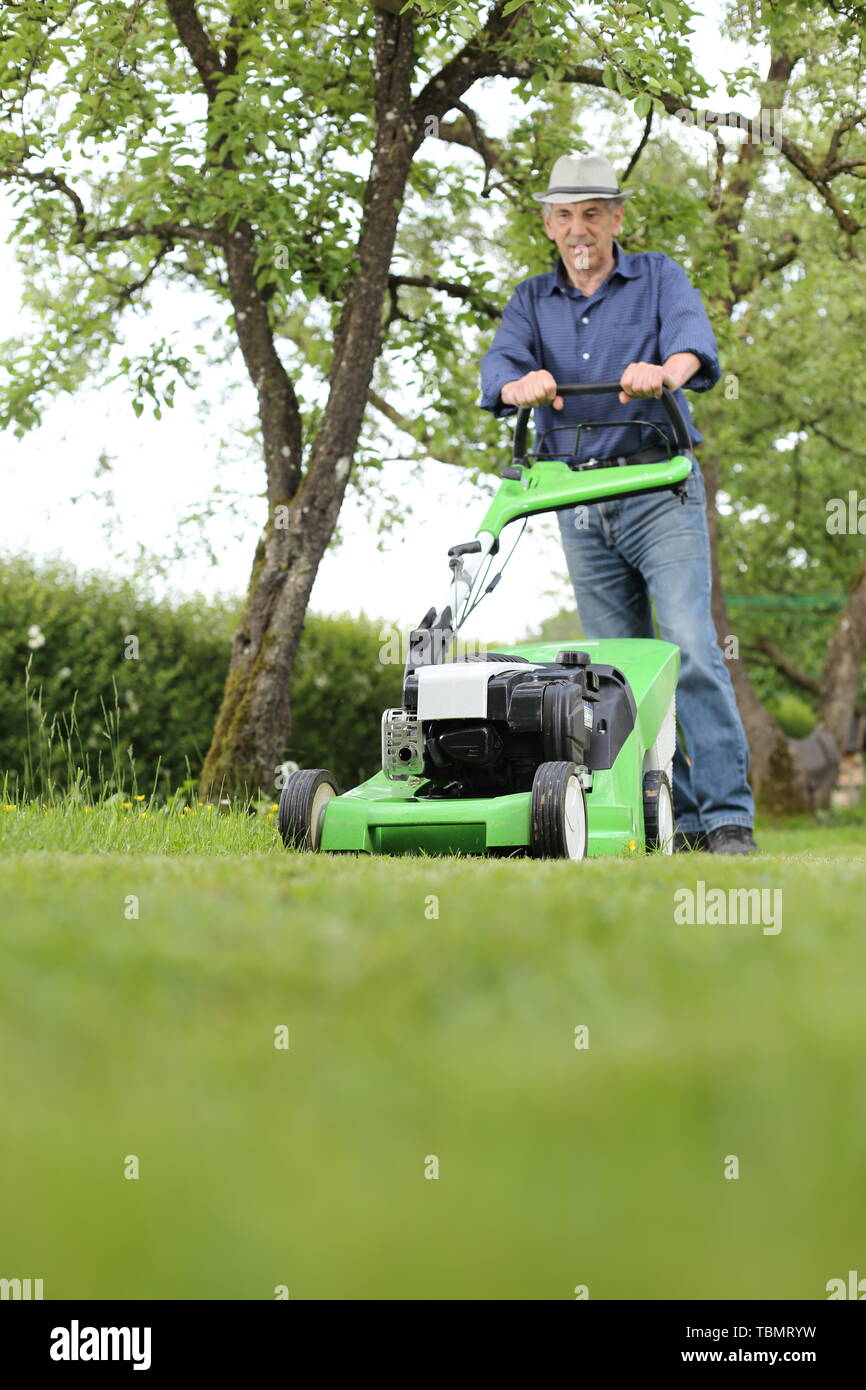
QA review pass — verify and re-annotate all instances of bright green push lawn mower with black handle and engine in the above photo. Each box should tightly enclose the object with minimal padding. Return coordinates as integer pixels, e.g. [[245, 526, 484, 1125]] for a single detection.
[[279, 382, 692, 859]]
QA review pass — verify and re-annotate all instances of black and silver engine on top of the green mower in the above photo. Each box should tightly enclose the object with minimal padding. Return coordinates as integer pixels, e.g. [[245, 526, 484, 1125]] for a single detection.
[[382, 651, 606, 796]]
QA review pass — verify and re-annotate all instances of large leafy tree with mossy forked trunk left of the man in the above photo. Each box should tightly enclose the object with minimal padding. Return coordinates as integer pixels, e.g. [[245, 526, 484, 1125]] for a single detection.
[[0, 0, 865, 806]]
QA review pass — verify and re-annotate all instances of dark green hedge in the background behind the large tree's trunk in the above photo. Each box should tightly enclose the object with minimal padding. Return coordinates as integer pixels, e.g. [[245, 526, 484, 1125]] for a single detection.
[[0, 555, 402, 795]]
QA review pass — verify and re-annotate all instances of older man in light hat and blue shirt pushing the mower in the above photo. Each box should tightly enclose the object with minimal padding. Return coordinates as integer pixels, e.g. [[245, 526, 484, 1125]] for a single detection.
[[481, 154, 758, 853]]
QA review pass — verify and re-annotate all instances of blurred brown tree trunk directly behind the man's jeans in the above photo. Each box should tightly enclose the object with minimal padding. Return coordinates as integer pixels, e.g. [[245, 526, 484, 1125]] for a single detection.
[[701, 443, 809, 815]]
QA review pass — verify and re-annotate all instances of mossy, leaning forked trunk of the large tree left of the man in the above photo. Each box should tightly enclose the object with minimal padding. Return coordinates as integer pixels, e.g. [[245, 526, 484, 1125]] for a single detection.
[[202, 14, 418, 795]]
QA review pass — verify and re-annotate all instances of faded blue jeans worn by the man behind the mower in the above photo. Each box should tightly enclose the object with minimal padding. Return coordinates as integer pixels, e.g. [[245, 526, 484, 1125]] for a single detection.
[[557, 460, 755, 831]]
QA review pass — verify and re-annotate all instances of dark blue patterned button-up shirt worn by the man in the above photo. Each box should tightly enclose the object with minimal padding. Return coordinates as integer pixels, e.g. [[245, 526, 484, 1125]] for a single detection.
[[480, 242, 720, 460]]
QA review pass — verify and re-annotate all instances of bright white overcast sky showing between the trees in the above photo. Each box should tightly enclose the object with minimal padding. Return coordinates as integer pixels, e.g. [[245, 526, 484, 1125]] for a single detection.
[[0, 6, 749, 642]]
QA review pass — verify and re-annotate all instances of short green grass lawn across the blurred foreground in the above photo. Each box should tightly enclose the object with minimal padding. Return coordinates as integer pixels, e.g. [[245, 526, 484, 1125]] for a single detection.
[[0, 802, 866, 1300]]
